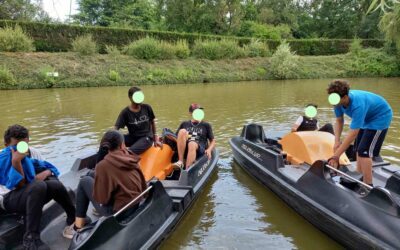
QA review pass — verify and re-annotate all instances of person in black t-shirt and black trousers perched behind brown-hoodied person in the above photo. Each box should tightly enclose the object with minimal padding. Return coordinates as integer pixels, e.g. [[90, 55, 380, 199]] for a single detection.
[[97, 87, 161, 162]]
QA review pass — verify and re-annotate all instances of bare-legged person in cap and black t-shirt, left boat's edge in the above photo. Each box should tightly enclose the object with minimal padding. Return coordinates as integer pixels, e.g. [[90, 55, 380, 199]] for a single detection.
[[174, 103, 215, 168]]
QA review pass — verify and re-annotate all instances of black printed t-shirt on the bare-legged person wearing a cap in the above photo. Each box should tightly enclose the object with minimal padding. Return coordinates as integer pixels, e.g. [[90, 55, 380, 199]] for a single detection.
[[177, 121, 214, 148]]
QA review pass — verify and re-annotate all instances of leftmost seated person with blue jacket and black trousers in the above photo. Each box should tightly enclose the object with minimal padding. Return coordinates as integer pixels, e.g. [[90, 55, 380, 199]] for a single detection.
[[0, 125, 75, 249]]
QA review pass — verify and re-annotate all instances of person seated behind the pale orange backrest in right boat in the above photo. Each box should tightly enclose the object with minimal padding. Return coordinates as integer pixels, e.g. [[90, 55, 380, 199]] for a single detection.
[[292, 103, 334, 134]]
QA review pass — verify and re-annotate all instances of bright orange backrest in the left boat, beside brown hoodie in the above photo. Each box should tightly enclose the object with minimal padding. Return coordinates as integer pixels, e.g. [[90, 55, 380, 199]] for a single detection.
[[139, 144, 174, 181]]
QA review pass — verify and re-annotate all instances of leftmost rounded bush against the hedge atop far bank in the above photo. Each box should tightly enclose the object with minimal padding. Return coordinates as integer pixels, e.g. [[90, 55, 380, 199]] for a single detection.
[[0, 25, 34, 52]]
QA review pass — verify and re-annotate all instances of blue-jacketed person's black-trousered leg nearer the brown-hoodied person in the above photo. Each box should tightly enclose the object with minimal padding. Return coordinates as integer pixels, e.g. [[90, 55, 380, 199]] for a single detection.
[[45, 177, 75, 225]]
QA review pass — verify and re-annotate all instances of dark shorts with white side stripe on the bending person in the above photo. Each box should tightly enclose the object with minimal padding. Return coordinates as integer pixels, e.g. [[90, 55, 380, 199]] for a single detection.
[[354, 129, 388, 158]]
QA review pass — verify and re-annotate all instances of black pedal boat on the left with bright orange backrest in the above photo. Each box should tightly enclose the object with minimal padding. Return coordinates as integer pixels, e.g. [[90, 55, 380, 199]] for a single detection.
[[0, 130, 218, 250]]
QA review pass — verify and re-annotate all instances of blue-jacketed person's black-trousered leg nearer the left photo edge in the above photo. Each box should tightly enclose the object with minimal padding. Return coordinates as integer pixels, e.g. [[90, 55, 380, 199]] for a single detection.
[[4, 181, 47, 237]]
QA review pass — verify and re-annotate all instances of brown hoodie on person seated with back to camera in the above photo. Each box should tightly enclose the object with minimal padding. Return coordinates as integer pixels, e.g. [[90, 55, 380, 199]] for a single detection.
[[93, 149, 147, 212]]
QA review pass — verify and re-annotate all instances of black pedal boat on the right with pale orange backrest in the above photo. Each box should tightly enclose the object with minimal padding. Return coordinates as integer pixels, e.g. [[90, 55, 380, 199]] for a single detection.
[[230, 124, 400, 249]]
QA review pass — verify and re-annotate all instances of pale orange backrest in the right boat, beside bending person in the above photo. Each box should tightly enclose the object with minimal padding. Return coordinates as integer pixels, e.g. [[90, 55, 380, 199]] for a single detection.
[[279, 131, 350, 165]]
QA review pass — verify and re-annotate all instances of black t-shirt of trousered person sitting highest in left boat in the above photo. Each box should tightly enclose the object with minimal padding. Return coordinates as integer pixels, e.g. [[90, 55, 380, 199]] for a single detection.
[[115, 104, 155, 137]]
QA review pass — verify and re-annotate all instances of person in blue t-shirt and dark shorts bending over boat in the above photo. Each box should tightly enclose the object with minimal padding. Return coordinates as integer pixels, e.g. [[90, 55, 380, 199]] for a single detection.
[[327, 80, 393, 186]]
